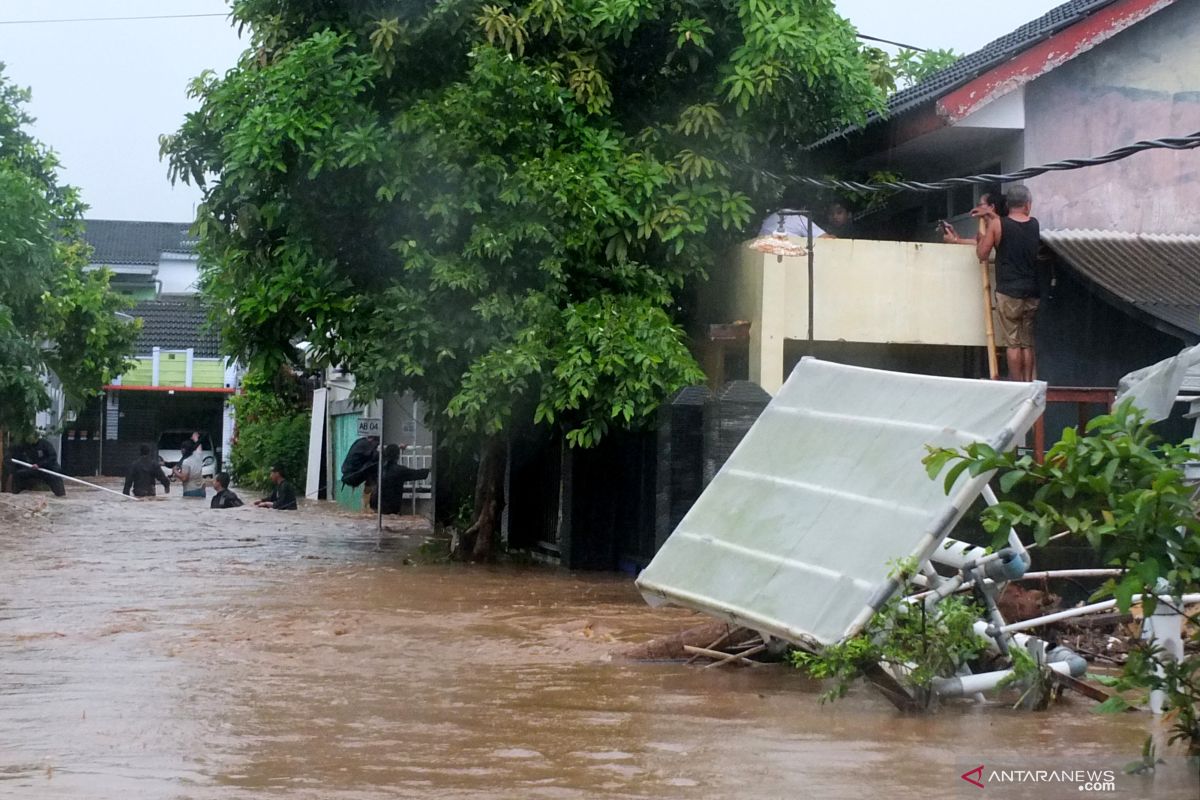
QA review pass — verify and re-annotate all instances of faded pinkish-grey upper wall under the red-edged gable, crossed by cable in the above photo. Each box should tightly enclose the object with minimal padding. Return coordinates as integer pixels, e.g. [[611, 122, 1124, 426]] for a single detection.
[[1025, 0, 1200, 233]]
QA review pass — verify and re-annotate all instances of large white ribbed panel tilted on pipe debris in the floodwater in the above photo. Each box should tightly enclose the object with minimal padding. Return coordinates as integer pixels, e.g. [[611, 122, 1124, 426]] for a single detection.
[[637, 359, 1045, 645]]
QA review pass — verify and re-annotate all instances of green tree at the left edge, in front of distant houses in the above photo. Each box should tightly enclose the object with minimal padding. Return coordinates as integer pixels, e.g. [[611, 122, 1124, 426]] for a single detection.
[[0, 65, 137, 435]]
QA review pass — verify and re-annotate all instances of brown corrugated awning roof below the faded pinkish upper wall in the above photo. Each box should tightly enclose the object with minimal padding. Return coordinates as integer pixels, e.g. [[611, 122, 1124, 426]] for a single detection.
[[1042, 230, 1200, 341]]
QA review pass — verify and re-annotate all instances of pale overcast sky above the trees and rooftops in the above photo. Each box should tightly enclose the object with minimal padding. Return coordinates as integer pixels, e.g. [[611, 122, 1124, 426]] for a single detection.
[[0, 0, 1060, 222]]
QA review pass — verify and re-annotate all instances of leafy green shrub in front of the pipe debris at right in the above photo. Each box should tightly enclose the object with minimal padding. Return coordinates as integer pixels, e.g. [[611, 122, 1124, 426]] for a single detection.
[[925, 401, 1200, 752]]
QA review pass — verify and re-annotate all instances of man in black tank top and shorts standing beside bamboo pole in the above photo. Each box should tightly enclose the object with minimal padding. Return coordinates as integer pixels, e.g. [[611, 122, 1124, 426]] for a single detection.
[[976, 186, 1042, 380]]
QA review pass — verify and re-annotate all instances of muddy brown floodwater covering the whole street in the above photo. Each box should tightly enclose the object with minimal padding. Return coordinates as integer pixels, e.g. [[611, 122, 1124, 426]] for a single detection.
[[0, 487, 1200, 800]]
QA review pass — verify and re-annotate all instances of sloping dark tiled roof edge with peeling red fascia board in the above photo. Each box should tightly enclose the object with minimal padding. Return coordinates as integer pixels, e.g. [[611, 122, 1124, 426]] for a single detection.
[[810, 0, 1174, 148]]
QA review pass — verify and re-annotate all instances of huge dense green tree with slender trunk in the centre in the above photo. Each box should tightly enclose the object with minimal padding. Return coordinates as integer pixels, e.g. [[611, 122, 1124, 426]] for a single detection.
[[163, 0, 881, 554]]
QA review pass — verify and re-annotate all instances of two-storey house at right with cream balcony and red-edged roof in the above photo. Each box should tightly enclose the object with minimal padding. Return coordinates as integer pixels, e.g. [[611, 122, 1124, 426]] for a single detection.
[[697, 0, 1200, 431]]
